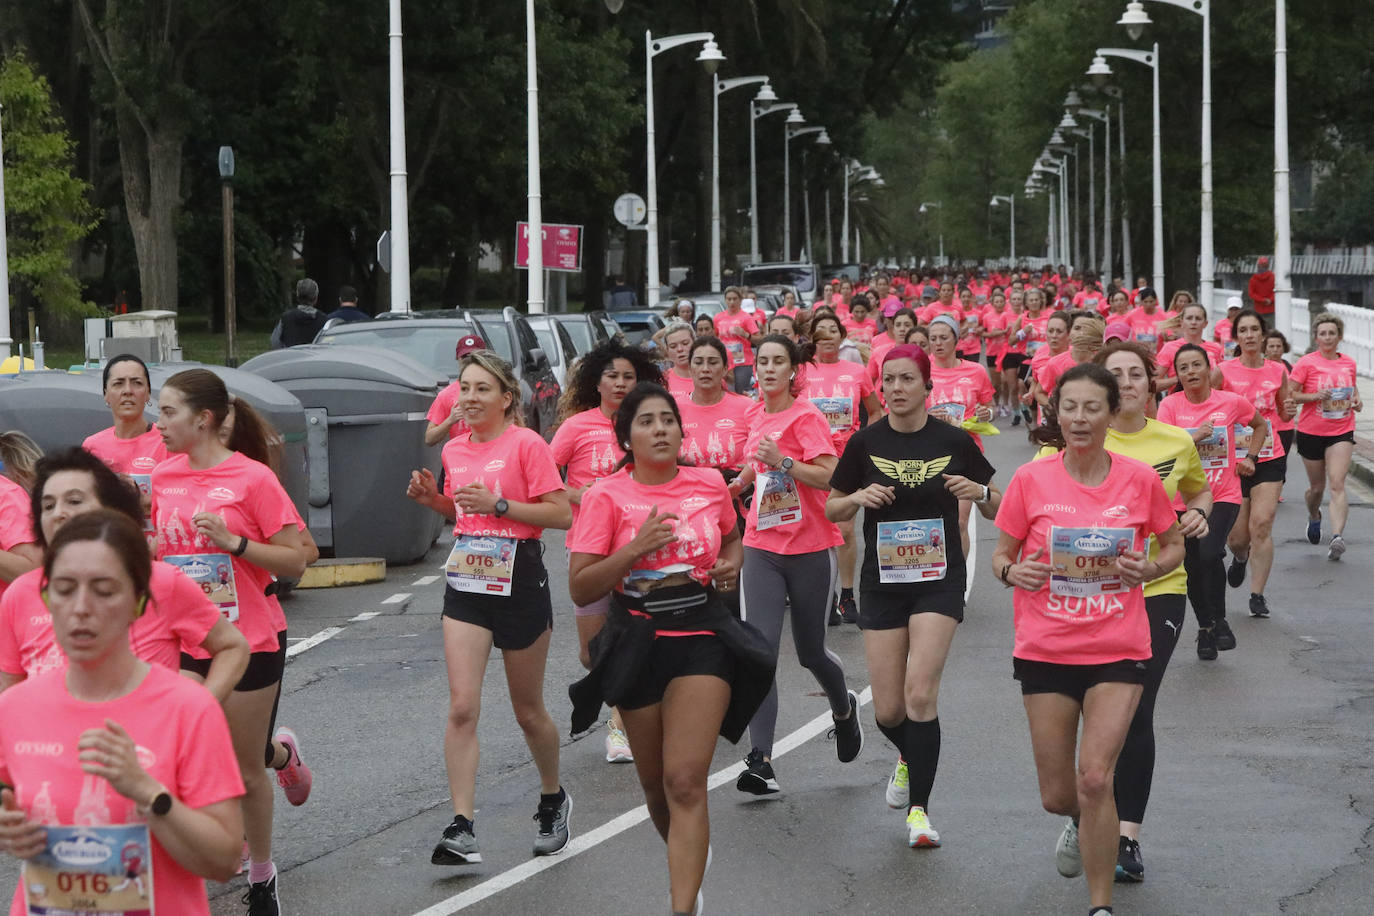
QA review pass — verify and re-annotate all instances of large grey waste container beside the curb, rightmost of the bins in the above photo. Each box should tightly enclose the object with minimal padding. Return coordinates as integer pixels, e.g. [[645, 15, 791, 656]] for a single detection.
[[243, 345, 442, 564]]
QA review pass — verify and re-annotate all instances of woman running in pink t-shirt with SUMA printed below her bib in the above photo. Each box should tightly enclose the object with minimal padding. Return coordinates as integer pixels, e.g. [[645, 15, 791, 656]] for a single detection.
[[992, 364, 1183, 916]]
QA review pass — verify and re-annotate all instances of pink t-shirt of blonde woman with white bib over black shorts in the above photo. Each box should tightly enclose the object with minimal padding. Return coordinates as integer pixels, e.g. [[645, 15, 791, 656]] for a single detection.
[[442, 425, 563, 540]]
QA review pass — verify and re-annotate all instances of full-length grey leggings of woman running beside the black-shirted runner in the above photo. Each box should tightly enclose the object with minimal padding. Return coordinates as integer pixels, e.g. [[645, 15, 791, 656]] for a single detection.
[[739, 547, 849, 757]]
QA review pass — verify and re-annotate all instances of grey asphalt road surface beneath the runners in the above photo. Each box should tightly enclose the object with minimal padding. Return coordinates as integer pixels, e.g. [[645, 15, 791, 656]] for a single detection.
[[0, 430, 1374, 916]]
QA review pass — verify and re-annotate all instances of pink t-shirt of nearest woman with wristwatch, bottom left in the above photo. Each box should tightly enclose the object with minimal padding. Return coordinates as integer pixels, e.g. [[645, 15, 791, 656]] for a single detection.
[[0, 665, 243, 916]]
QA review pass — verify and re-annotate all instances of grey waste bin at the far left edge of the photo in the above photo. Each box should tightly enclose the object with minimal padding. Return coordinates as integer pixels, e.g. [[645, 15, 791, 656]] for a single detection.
[[0, 371, 114, 452]]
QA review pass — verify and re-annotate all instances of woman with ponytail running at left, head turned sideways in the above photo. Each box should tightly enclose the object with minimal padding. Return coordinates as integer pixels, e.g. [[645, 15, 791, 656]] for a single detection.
[[153, 369, 305, 916]]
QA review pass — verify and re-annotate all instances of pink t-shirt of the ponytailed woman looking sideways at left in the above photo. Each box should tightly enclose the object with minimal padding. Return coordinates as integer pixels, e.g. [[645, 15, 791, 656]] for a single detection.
[[153, 452, 300, 658]]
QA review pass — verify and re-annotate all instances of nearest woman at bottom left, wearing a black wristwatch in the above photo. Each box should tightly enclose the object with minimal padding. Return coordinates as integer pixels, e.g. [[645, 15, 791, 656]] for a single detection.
[[0, 509, 244, 916]]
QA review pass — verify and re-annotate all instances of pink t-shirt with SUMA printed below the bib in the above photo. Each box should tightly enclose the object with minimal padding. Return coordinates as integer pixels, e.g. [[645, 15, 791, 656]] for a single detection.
[[996, 452, 1176, 665]]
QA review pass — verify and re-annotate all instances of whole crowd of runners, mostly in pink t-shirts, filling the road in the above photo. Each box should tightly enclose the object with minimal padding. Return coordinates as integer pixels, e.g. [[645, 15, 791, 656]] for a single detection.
[[0, 268, 1363, 916]]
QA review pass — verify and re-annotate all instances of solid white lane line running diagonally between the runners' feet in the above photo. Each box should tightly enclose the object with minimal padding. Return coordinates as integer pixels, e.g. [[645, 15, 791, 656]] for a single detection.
[[415, 516, 978, 916]]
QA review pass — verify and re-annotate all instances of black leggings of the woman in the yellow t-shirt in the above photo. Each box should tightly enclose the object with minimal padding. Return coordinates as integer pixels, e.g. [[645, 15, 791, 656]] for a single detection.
[[1114, 595, 1187, 824]]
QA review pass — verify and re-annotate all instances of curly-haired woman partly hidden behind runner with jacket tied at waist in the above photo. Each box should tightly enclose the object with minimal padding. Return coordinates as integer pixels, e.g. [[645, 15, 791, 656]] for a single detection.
[[550, 340, 659, 764]]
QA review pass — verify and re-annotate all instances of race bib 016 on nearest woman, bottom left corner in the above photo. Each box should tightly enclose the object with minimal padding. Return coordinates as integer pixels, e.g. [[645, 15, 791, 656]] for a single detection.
[[23, 824, 155, 916]]
